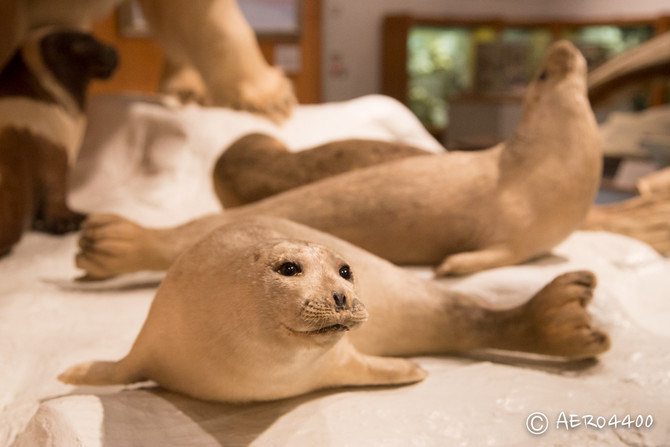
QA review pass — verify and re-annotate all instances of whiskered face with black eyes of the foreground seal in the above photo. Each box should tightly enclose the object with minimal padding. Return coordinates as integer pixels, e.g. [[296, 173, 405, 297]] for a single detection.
[[256, 240, 367, 345]]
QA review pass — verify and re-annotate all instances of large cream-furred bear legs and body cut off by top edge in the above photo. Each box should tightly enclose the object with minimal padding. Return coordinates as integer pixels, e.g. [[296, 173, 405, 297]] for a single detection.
[[0, 0, 296, 122]]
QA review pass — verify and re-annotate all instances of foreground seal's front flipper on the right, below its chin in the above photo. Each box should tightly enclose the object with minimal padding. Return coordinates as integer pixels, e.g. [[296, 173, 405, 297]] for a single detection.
[[322, 342, 428, 388]]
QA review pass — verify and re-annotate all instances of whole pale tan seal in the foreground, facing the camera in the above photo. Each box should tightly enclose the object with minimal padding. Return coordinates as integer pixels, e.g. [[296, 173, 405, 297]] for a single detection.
[[59, 217, 609, 401]]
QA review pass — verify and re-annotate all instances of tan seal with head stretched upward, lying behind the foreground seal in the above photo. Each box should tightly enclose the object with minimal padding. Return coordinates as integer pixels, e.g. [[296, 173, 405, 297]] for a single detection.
[[77, 41, 602, 277]]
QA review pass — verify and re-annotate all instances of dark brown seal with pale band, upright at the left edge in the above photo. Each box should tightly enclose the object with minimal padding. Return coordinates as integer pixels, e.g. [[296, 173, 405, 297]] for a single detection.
[[0, 30, 117, 254]]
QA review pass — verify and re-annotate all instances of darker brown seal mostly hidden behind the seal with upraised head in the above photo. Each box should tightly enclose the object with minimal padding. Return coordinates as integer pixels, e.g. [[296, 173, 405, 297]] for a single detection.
[[214, 133, 432, 208]]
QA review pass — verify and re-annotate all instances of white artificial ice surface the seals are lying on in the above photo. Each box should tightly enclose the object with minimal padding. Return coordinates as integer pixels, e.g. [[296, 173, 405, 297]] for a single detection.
[[0, 93, 670, 447]]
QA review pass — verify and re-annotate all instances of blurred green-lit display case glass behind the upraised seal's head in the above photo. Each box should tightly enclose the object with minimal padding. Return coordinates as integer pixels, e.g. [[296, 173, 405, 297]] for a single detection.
[[407, 25, 654, 129]]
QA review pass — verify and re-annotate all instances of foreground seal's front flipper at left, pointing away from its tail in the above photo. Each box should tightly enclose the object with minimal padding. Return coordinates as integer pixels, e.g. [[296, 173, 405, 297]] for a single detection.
[[58, 359, 145, 385]]
